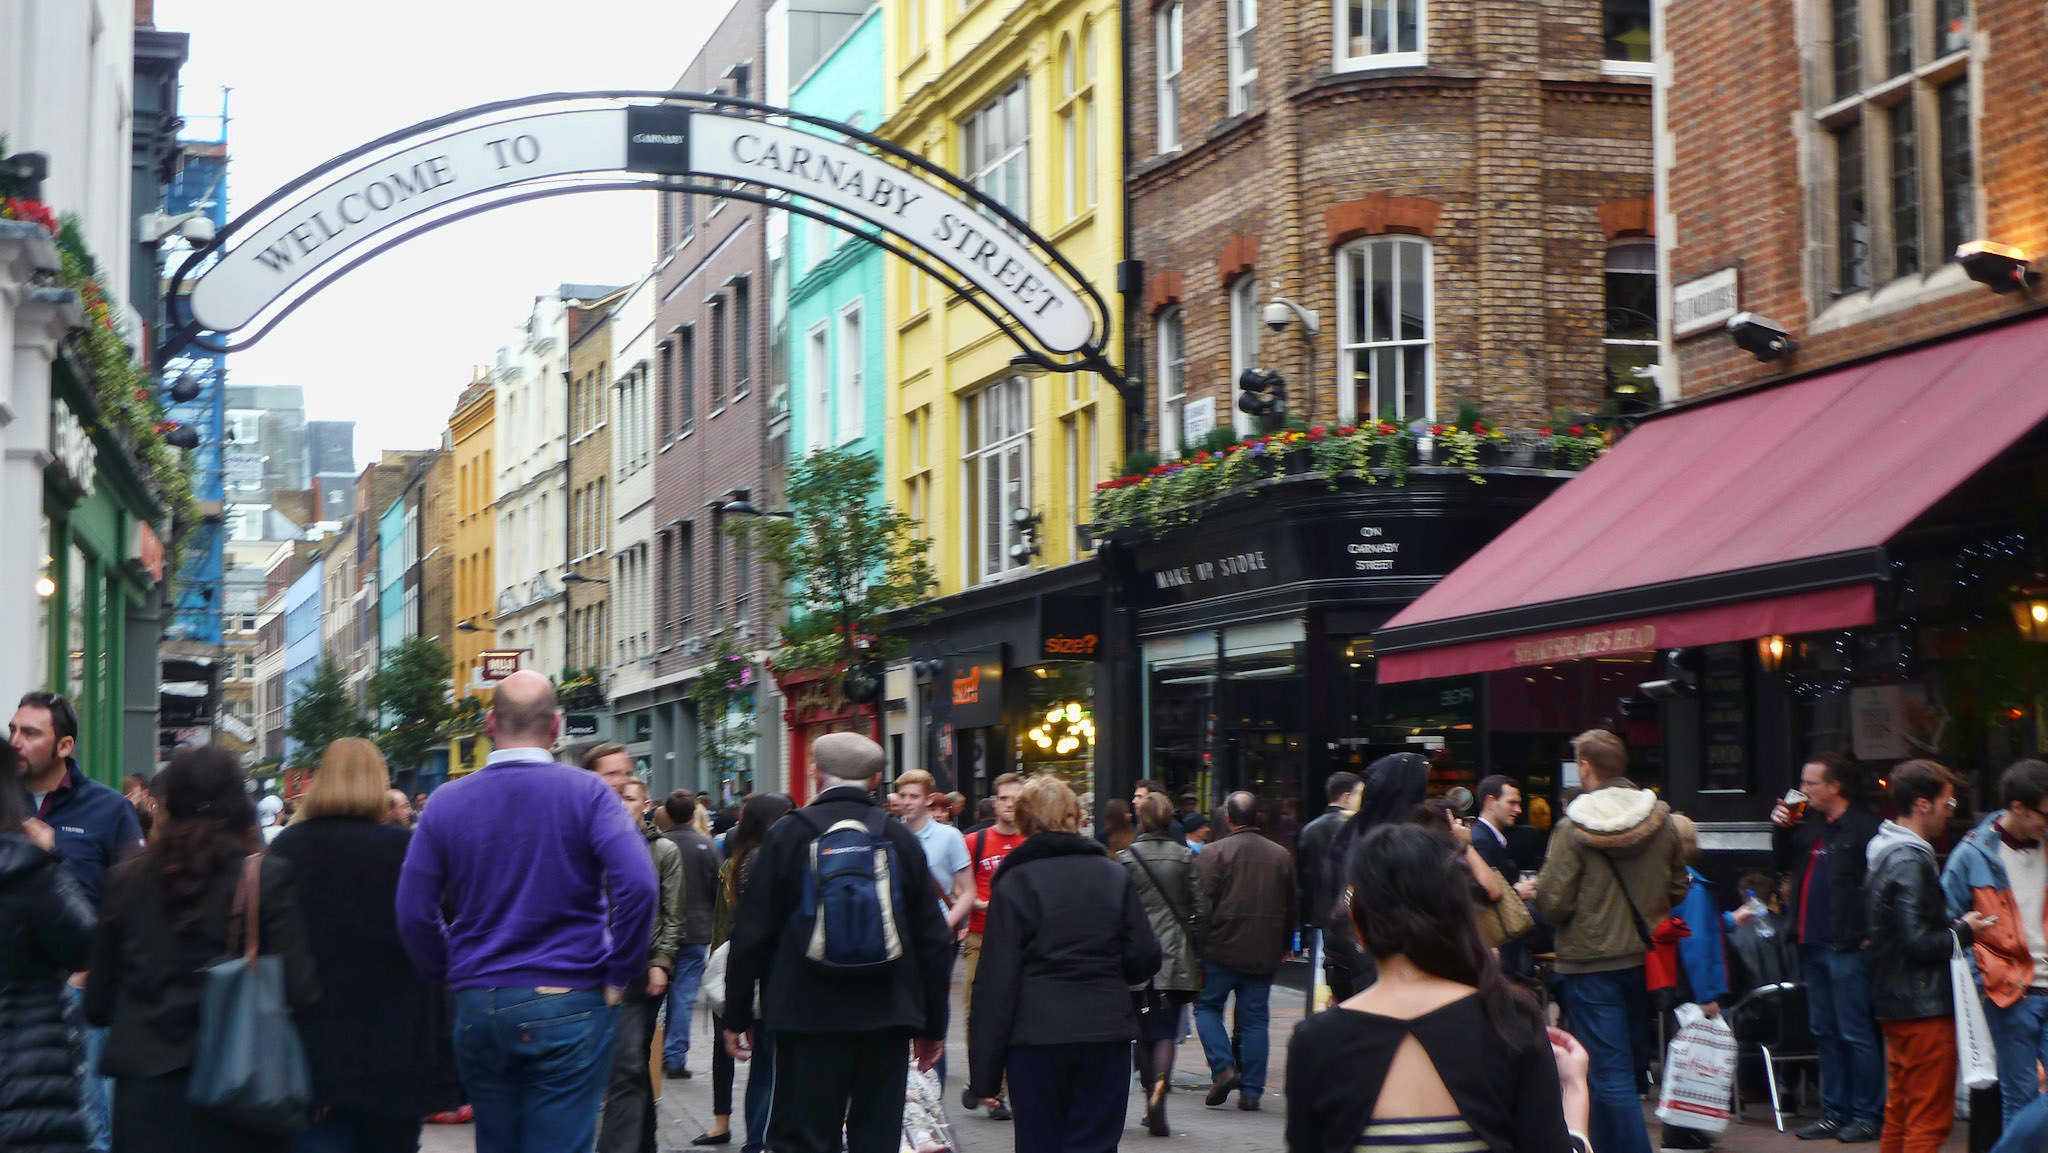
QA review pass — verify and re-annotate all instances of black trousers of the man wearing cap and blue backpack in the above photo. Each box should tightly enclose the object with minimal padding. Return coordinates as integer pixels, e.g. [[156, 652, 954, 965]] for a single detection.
[[754, 1030, 909, 1153]]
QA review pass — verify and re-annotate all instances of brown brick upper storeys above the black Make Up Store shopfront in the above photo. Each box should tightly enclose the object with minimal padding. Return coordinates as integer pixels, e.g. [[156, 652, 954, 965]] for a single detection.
[[1128, 0, 1655, 438]]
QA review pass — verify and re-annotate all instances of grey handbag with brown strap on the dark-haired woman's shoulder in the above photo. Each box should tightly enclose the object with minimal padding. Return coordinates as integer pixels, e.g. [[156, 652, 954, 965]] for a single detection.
[[184, 854, 313, 1133]]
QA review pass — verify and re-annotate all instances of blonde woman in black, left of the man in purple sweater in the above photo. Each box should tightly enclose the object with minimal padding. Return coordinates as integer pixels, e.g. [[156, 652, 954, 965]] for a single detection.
[[270, 737, 463, 1153]]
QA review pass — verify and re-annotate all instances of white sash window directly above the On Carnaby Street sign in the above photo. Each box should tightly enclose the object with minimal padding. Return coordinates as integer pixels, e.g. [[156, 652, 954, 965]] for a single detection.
[[1337, 236, 1436, 426]]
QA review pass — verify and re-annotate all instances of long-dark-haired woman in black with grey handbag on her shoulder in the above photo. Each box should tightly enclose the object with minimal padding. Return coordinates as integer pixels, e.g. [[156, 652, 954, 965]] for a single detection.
[[86, 745, 319, 1153]]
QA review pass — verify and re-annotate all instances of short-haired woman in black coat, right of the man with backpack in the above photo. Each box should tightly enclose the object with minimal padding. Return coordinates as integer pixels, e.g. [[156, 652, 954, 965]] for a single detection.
[[967, 776, 1159, 1153]]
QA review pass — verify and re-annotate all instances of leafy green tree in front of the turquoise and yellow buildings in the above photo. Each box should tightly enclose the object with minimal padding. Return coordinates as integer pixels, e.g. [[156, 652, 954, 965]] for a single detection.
[[727, 449, 936, 668]]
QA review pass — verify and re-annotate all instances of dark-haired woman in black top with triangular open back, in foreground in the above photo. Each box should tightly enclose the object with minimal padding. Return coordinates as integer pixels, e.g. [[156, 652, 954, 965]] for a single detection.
[[1286, 823, 1591, 1153]]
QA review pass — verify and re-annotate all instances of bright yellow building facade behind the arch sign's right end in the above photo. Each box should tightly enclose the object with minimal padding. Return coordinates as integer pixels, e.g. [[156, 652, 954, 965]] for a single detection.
[[874, 0, 1124, 596]]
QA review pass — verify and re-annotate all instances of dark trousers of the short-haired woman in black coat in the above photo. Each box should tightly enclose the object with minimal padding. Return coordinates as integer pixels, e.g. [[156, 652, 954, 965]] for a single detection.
[[1004, 1040, 1130, 1153]]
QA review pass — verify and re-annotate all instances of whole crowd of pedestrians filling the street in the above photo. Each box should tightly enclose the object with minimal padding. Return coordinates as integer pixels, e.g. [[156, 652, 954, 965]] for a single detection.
[[19, 672, 2048, 1153]]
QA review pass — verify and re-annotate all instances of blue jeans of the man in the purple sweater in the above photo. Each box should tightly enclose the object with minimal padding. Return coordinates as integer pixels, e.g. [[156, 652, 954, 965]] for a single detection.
[[455, 989, 618, 1153]]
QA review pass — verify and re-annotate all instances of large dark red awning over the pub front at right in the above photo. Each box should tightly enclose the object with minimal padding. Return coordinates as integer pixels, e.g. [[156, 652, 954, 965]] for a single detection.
[[1374, 317, 2048, 684]]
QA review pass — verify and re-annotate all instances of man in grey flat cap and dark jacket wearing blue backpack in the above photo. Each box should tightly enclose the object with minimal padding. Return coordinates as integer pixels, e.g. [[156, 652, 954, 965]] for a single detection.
[[725, 733, 952, 1153]]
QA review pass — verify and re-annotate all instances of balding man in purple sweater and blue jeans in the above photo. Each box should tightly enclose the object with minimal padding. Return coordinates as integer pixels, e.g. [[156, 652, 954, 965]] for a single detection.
[[397, 672, 655, 1153]]
